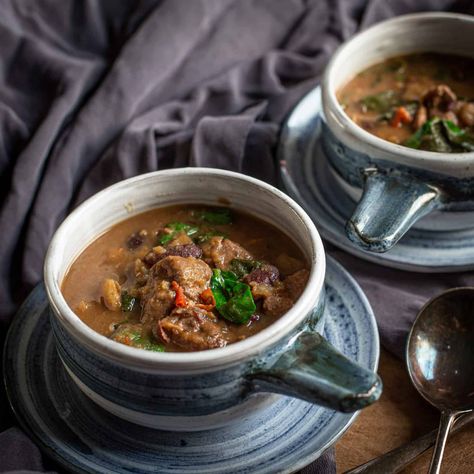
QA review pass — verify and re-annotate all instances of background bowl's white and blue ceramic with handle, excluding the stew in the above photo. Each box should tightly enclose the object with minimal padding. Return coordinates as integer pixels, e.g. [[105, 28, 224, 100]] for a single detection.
[[322, 13, 474, 252]]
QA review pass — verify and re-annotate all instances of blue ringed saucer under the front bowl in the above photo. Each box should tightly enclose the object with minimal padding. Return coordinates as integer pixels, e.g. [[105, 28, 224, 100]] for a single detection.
[[4, 257, 379, 474]]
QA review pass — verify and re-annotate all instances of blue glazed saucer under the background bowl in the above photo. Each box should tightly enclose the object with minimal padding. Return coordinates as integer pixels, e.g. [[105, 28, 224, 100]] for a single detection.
[[278, 87, 474, 273]]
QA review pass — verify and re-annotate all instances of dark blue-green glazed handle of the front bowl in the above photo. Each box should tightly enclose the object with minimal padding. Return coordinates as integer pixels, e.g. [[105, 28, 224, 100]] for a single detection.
[[247, 331, 382, 412]]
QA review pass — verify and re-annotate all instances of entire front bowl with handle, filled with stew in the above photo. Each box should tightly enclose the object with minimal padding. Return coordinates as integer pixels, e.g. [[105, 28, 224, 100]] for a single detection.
[[44, 168, 382, 431]]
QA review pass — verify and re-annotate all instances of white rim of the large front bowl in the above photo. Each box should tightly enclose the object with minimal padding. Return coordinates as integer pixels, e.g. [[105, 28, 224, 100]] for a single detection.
[[44, 167, 326, 373]]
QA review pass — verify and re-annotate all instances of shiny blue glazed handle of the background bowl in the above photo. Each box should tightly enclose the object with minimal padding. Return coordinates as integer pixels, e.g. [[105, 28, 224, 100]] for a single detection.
[[346, 168, 443, 252]]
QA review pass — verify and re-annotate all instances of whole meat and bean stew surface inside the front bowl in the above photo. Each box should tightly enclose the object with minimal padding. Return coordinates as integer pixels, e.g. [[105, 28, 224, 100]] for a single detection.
[[62, 206, 309, 352]]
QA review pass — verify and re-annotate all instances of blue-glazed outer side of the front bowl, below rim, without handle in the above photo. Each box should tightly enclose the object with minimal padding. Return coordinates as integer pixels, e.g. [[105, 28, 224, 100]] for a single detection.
[[51, 295, 326, 431]]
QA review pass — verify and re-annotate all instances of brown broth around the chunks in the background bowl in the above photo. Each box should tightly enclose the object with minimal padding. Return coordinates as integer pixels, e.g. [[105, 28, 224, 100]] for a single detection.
[[337, 53, 474, 149]]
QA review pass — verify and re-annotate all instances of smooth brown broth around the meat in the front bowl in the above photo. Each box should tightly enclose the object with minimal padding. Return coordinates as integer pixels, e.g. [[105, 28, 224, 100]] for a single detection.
[[62, 205, 307, 351]]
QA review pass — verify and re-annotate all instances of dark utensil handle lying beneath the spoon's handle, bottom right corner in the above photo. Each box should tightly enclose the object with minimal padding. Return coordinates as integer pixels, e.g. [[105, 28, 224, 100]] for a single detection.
[[344, 413, 474, 474]]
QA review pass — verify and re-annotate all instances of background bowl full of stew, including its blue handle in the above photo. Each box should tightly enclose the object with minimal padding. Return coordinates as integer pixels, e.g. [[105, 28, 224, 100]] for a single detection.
[[321, 12, 474, 252]]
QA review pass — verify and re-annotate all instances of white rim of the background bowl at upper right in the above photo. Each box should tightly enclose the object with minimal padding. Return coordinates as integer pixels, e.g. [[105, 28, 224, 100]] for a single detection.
[[321, 12, 474, 169]]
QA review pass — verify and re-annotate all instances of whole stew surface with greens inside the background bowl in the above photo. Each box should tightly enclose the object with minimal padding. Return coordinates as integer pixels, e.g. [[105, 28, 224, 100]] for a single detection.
[[337, 53, 474, 153]]
